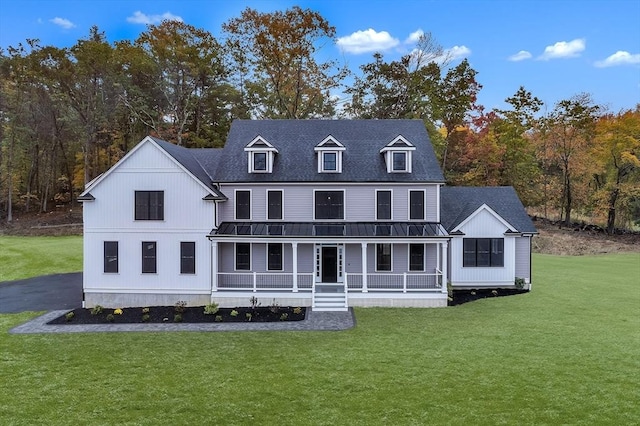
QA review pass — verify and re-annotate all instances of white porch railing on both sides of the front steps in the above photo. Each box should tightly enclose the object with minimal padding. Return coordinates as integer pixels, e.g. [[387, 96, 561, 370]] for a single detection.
[[217, 270, 442, 293]]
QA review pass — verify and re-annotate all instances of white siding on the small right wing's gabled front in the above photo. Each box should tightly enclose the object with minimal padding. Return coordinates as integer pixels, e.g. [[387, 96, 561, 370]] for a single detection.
[[449, 210, 518, 287]]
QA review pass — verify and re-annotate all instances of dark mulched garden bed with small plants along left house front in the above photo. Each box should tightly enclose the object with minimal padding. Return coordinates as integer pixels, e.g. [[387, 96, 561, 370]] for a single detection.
[[47, 306, 306, 325]]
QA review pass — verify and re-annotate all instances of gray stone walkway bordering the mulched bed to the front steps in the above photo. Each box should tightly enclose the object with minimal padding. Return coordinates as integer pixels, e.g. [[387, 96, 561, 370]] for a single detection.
[[9, 308, 356, 334]]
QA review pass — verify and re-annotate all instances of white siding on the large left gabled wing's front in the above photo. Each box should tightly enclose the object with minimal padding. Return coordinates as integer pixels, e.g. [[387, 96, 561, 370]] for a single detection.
[[83, 141, 215, 294]]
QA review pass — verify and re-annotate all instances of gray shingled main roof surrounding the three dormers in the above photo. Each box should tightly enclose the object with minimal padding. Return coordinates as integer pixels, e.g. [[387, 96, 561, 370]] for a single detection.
[[215, 120, 444, 182]]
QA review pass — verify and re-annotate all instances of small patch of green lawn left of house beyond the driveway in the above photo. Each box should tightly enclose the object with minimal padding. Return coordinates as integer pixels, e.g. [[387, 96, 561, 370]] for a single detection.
[[0, 236, 82, 282]]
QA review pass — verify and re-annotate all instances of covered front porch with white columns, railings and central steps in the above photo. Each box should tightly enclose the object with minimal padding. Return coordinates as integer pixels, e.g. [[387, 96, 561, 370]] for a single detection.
[[209, 223, 448, 310]]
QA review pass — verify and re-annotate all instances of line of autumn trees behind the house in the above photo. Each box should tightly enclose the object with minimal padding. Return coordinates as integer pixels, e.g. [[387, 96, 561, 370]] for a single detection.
[[0, 7, 640, 232]]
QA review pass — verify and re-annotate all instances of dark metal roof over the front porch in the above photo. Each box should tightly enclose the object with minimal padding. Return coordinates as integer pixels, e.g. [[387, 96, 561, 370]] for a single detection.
[[209, 222, 446, 238]]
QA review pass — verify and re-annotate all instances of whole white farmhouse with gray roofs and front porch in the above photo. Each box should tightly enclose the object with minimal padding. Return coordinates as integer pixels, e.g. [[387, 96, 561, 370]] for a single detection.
[[79, 120, 536, 310]]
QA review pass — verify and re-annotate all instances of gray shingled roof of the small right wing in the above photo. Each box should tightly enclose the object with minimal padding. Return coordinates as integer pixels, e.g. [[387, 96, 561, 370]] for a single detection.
[[440, 186, 537, 233]]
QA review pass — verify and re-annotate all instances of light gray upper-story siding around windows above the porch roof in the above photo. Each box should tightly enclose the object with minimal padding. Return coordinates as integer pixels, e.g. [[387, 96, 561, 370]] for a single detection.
[[218, 183, 439, 222]]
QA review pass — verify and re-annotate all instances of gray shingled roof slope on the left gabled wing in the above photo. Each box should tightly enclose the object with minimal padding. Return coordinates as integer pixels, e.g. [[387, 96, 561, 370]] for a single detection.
[[151, 137, 226, 199]]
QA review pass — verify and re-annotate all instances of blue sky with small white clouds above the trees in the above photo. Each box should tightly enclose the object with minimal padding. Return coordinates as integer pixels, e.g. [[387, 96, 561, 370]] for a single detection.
[[0, 0, 640, 112]]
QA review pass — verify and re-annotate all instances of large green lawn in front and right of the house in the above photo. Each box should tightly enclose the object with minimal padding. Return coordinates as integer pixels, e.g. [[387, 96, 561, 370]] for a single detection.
[[0, 254, 640, 425]]
